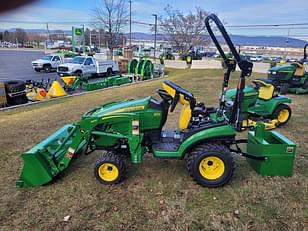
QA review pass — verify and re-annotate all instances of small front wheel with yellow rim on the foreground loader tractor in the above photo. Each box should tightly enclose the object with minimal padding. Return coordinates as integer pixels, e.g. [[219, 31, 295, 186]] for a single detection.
[[94, 152, 126, 185]]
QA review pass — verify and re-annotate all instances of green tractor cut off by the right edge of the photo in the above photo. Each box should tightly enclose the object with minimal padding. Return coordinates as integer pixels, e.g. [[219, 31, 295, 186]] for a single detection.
[[268, 44, 308, 94]]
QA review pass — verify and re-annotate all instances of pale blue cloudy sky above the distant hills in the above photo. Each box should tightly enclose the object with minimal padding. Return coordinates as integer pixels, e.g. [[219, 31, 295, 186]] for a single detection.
[[0, 0, 308, 37]]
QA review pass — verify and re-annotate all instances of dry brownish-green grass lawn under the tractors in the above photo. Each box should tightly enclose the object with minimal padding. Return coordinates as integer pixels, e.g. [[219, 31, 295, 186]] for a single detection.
[[0, 67, 308, 230]]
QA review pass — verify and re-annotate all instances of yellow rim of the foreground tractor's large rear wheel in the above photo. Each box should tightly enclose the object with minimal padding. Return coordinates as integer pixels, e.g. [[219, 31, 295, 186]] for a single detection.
[[199, 156, 225, 180]]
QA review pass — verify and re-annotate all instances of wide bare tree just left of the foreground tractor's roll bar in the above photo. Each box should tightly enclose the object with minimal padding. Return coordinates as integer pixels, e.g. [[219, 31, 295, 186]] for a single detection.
[[159, 5, 210, 51]]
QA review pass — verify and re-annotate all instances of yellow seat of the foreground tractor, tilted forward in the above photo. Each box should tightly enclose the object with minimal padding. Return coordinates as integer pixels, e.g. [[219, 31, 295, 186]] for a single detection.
[[162, 83, 191, 130]]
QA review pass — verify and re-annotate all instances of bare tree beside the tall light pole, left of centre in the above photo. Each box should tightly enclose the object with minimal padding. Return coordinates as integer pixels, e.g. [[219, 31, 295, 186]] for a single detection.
[[93, 0, 129, 51]]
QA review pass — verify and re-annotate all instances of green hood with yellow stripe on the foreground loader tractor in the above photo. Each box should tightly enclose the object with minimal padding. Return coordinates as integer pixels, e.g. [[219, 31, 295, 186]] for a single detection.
[[83, 96, 151, 118]]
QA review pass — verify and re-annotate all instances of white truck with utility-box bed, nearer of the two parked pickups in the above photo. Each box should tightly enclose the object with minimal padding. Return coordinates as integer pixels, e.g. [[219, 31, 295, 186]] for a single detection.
[[57, 56, 119, 76]]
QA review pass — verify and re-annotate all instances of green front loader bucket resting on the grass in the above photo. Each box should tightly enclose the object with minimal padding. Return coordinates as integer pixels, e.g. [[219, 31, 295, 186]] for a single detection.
[[16, 124, 80, 187]]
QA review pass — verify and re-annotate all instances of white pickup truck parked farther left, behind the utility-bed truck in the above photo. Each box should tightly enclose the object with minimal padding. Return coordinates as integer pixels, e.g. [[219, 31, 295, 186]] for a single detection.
[[32, 54, 64, 72]]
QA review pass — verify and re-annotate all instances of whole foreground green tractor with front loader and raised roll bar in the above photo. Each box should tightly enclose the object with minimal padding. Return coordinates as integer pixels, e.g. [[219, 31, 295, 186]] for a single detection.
[[16, 14, 296, 187]]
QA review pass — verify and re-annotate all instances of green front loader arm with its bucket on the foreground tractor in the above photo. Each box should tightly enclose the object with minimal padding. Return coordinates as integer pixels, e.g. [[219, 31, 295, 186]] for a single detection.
[[16, 112, 143, 187]]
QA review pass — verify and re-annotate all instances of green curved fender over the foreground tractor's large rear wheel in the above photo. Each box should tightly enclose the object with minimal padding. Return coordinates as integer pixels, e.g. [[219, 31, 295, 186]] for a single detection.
[[178, 124, 236, 158]]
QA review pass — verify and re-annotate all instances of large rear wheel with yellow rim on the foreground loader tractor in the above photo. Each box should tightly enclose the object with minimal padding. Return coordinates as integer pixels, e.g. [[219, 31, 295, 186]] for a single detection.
[[186, 144, 235, 188]]
